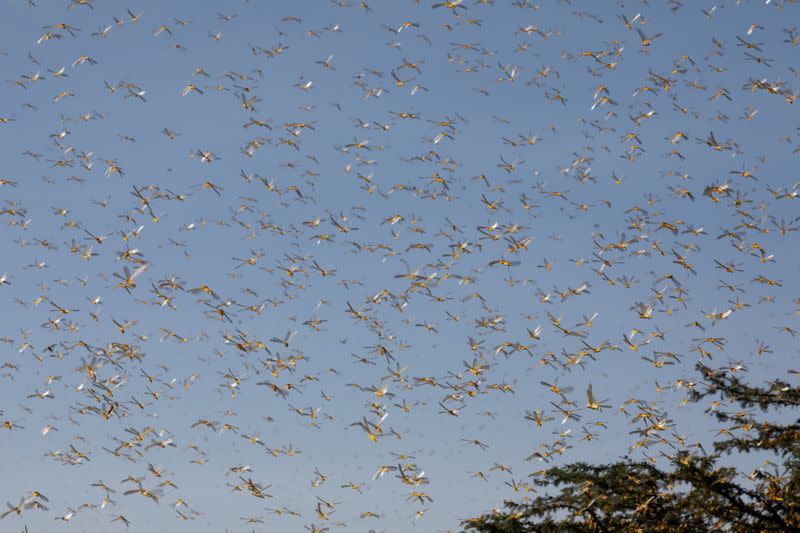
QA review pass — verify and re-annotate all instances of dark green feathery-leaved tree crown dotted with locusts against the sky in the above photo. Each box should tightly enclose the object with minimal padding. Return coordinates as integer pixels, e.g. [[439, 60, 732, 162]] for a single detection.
[[462, 364, 800, 533]]
